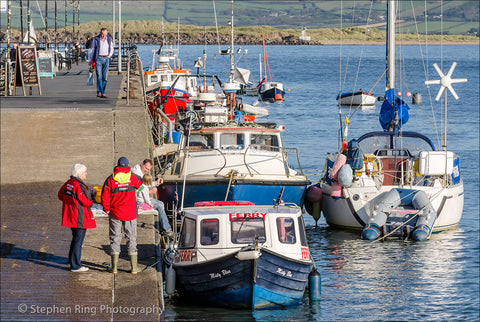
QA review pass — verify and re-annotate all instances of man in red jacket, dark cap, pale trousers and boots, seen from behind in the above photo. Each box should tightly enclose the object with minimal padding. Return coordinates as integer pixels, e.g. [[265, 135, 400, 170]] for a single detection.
[[102, 157, 143, 274]]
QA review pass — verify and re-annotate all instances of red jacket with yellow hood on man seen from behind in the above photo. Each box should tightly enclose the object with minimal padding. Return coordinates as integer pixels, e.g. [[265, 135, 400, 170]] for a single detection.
[[102, 167, 143, 221]]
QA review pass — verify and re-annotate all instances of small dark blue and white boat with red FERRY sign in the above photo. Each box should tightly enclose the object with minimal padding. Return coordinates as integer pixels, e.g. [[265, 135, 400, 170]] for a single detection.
[[172, 201, 314, 310]]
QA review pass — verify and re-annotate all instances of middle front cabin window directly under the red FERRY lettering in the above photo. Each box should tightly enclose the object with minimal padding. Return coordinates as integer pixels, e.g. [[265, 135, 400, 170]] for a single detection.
[[231, 217, 265, 244]]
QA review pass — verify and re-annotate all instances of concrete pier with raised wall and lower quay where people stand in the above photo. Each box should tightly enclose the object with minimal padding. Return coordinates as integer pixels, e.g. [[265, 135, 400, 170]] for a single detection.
[[0, 62, 164, 321]]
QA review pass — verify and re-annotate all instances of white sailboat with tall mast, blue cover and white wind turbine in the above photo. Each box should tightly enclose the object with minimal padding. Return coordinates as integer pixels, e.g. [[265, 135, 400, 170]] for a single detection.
[[307, 0, 464, 241]]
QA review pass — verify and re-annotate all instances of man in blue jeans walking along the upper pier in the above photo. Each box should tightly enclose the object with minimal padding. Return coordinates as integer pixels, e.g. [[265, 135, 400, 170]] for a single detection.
[[88, 28, 114, 98]]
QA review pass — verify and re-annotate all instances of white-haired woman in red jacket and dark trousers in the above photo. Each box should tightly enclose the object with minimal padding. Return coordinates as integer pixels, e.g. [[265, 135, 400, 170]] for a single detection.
[[58, 163, 97, 272]]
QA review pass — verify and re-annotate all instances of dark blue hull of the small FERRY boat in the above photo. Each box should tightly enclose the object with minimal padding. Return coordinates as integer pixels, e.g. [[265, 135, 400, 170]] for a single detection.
[[174, 250, 312, 310]]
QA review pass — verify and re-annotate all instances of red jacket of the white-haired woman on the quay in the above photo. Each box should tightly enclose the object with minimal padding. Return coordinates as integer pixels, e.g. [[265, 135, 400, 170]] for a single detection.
[[58, 177, 97, 228]]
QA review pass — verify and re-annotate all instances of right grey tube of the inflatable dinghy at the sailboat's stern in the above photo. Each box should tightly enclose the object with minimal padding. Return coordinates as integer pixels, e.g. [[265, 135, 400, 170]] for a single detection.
[[412, 191, 437, 241]]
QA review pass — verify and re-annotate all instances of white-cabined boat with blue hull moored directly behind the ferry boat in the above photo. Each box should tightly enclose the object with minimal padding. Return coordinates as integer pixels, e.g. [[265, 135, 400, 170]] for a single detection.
[[155, 92, 310, 209]]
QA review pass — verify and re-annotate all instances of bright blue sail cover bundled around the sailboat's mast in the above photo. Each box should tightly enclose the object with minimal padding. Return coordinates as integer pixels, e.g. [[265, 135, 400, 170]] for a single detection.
[[379, 88, 410, 131]]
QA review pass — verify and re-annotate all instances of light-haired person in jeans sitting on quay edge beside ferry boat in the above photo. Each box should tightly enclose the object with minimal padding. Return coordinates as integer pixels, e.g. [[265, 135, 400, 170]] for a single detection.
[[132, 159, 173, 238]]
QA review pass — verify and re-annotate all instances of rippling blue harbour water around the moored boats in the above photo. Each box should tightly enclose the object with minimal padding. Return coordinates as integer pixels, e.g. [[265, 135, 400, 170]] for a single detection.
[[139, 45, 480, 321]]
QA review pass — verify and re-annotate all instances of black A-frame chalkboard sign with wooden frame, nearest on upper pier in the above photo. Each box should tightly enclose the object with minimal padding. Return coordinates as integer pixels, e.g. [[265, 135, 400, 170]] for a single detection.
[[13, 46, 42, 96]]
